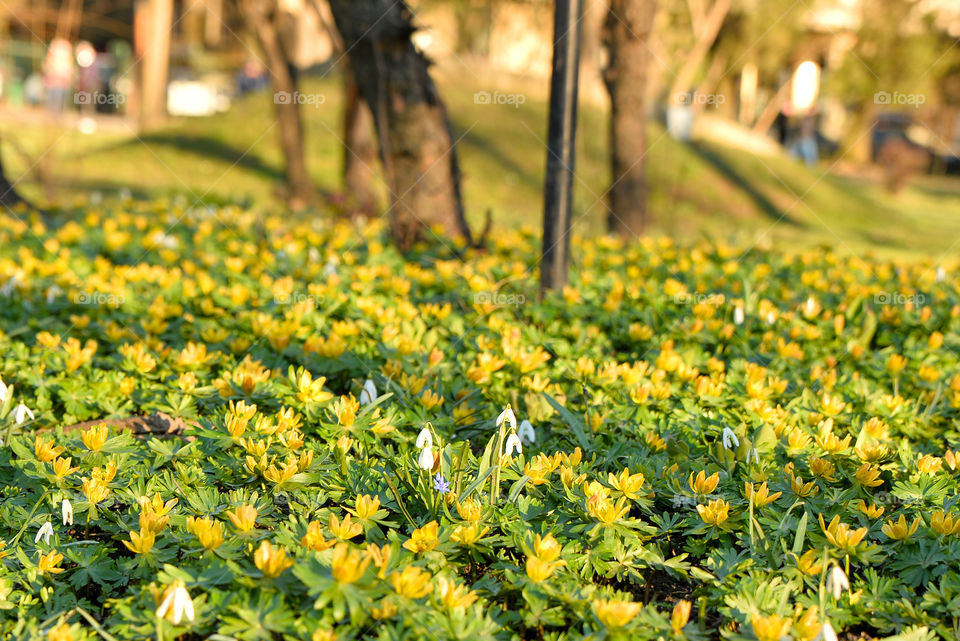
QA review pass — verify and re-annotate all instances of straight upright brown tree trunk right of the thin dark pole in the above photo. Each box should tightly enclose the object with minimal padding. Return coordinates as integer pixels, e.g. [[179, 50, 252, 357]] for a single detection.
[[604, 0, 657, 238]]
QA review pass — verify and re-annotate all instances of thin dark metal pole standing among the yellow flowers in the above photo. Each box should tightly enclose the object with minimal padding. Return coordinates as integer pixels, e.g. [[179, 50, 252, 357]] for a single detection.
[[540, 0, 582, 297]]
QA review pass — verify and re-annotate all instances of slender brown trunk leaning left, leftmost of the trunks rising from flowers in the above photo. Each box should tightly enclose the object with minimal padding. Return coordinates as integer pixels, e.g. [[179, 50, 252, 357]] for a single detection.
[[241, 0, 313, 209]]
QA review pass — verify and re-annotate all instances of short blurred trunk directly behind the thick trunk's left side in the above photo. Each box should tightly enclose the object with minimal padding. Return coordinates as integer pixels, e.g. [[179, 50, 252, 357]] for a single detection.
[[343, 64, 378, 216]]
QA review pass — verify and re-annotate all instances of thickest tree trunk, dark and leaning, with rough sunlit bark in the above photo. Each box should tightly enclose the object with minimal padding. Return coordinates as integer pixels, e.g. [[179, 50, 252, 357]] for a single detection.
[[330, 0, 472, 249]]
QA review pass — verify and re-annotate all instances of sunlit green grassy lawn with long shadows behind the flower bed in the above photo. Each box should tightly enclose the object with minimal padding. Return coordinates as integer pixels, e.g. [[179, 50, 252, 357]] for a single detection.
[[2, 69, 960, 260]]
